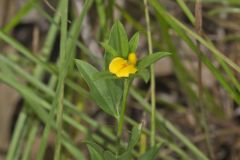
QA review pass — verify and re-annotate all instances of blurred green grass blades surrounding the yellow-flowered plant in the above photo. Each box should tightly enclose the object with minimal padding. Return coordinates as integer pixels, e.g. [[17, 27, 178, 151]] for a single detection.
[[0, 0, 240, 160]]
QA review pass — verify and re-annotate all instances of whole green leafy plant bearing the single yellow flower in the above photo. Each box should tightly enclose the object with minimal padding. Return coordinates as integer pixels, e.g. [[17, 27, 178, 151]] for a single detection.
[[76, 21, 170, 160]]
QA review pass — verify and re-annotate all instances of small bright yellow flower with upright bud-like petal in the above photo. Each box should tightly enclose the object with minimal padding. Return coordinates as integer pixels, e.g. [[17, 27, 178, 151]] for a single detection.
[[109, 53, 137, 78]]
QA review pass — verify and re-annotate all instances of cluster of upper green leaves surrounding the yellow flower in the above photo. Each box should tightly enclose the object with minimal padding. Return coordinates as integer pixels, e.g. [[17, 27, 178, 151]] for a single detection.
[[76, 21, 170, 118]]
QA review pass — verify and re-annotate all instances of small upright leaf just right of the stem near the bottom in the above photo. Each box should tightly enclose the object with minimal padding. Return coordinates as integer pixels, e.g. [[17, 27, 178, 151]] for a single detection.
[[128, 124, 142, 150]]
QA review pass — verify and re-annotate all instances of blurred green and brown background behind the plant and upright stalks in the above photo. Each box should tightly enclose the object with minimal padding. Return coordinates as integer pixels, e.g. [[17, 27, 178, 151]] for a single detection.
[[0, 0, 240, 160]]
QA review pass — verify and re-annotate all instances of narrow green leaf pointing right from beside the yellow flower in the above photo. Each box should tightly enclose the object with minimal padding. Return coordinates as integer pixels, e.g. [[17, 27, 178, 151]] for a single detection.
[[137, 52, 171, 70]]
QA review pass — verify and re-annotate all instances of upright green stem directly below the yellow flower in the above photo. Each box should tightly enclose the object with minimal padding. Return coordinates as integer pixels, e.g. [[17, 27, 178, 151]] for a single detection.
[[117, 79, 131, 154]]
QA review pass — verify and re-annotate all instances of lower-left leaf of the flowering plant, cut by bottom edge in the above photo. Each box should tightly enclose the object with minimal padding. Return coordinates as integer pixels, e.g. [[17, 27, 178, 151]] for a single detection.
[[86, 141, 104, 160]]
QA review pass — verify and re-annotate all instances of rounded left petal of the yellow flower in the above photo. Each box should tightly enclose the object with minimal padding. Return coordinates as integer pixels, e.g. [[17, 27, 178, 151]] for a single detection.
[[109, 57, 128, 74]]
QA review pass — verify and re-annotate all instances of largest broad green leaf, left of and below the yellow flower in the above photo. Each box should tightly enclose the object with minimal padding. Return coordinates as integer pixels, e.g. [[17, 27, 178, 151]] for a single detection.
[[76, 60, 122, 117]]
